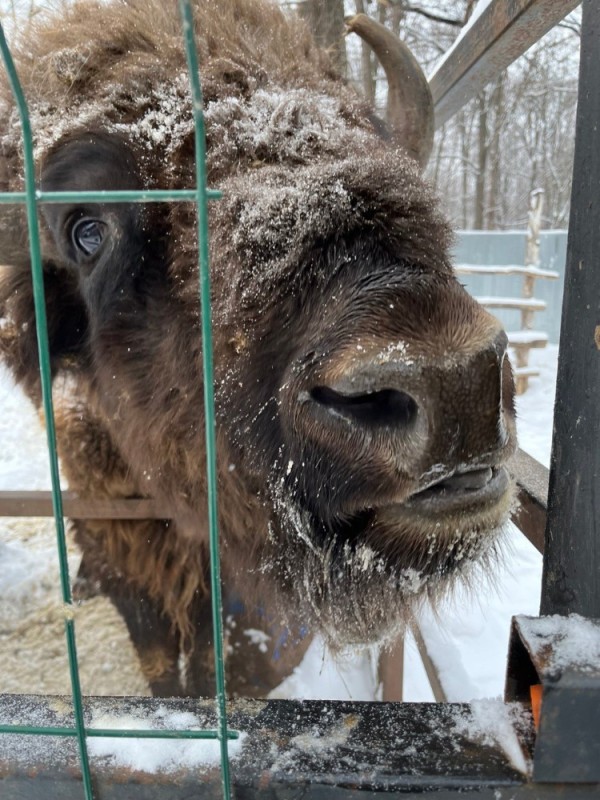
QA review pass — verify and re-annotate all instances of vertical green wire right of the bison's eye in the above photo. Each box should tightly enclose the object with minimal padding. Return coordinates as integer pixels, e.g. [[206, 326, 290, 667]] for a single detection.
[[179, 0, 231, 800]]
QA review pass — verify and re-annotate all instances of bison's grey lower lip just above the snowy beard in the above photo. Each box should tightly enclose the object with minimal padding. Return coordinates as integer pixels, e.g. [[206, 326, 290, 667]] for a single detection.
[[403, 467, 509, 513]]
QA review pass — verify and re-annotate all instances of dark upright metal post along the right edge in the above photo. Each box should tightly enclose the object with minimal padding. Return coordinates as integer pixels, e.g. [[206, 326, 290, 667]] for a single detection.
[[542, 0, 600, 617]]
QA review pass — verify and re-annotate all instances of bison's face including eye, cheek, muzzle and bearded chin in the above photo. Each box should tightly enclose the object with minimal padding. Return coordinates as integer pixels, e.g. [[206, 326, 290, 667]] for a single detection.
[[32, 132, 515, 643]]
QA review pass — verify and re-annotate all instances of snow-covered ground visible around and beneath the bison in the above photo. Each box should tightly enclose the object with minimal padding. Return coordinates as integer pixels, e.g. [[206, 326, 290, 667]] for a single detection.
[[0, 346, 557, 701]]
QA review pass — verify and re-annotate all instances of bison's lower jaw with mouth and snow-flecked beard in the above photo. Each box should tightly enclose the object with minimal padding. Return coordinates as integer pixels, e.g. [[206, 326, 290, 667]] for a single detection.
[[268, 466, 513, 647]]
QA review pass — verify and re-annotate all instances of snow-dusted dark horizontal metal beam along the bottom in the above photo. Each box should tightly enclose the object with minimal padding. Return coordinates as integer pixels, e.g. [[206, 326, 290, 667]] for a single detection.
[[0, 695, 528, 800]]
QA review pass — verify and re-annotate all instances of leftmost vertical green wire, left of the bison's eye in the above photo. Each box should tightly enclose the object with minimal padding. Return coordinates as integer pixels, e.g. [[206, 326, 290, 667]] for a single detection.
[[0, 24, 93, 800]]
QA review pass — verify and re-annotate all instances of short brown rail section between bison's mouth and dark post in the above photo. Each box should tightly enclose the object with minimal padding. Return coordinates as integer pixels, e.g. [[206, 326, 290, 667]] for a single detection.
[[510, 450, 549, 553]]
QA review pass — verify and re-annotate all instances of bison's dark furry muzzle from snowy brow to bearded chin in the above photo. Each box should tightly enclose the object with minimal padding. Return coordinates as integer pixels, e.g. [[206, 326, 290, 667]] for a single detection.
[[214, 156, 516, 643]]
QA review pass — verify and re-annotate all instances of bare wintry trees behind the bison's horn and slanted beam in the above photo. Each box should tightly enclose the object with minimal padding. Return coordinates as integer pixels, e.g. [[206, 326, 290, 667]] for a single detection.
[[296, 0, 581, 230]]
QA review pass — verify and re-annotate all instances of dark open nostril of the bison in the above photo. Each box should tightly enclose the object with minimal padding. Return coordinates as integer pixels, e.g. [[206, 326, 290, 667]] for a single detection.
[[310, 386, 418, 427]]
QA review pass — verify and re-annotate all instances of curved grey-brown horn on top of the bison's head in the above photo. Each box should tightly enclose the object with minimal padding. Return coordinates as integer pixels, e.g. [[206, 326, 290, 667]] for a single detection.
[[345, 14, 434, 168]]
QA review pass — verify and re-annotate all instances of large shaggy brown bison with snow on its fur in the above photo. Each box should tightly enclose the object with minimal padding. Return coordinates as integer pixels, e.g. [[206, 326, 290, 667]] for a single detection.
[[0, 0, 515, 695]]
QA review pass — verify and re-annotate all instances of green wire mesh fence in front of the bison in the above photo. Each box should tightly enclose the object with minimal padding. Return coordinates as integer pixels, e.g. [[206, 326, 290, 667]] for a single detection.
[[0, 0, 239, 800]]
